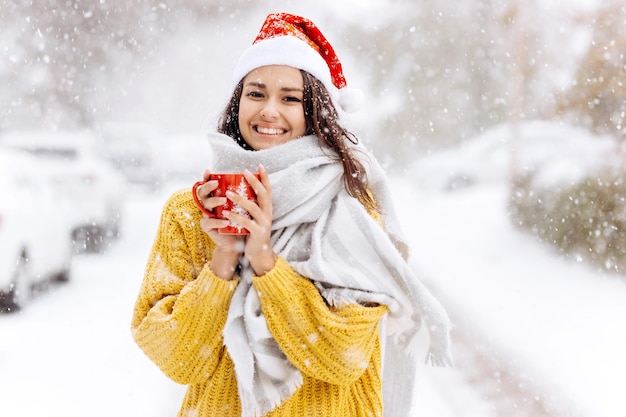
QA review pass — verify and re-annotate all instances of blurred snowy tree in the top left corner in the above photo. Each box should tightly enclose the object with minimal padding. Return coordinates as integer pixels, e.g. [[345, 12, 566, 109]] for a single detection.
[[0, 0, 252, 130]]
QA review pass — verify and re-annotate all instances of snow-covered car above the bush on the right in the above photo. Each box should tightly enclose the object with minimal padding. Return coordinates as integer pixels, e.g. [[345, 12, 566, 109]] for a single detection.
[[410, 121, 617, 191]]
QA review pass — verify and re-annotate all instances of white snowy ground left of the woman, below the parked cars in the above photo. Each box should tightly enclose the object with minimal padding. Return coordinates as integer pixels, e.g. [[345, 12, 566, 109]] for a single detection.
[[0, 189, 180, 417]]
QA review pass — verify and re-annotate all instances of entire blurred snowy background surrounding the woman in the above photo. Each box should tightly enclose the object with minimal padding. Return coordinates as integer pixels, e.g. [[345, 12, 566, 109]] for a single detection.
[[0, 0, 626, 417]]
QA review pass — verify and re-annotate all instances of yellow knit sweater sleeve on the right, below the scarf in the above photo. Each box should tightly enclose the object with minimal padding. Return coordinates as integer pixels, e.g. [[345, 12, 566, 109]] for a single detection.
[[253, 258, 387, 385]]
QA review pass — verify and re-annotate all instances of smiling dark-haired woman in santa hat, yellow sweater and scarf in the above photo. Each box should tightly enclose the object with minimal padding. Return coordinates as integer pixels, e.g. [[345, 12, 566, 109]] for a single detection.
[[132, 13, 450, 417]]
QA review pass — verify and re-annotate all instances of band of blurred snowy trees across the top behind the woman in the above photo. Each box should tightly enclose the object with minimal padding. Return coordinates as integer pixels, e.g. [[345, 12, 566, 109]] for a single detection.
[[0, 0, 626, 166]]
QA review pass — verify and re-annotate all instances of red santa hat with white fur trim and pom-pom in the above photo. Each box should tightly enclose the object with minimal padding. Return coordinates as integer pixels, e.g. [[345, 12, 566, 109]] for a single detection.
[[232, 13, 361, 112]]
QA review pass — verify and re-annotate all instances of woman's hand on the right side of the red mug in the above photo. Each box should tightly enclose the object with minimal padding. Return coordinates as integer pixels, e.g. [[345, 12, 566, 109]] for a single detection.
[[226, 165, 276, 276]]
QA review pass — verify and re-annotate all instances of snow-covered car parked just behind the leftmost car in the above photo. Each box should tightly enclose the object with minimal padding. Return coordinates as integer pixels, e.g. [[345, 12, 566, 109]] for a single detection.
[[0, 131, 125, 253]]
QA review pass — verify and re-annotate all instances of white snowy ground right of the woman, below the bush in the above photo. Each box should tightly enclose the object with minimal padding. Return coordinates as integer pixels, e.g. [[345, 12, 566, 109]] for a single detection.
[[395, 182, 626, 417]]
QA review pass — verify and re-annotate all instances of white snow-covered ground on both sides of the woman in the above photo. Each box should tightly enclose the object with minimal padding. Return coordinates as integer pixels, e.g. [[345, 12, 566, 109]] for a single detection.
[[0, 179, 626, 417]]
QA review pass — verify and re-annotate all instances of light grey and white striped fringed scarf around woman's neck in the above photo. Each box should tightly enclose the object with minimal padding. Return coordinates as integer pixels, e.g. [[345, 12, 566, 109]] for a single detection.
[[210, 134, 451, 417]]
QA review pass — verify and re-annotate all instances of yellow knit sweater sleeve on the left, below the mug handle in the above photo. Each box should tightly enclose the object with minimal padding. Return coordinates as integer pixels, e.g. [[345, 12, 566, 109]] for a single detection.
[[131, 188, 237, 384]]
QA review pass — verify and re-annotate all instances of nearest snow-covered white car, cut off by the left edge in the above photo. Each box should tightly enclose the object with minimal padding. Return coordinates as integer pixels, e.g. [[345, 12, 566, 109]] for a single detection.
[[0, 149, 73, 311]]
